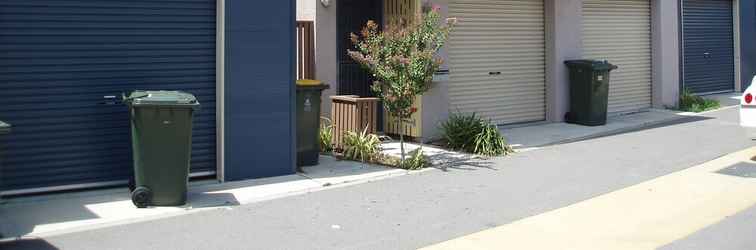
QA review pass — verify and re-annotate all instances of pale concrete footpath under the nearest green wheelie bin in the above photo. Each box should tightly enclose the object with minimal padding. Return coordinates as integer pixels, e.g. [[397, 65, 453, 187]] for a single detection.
[[0, 156, 408, 239]]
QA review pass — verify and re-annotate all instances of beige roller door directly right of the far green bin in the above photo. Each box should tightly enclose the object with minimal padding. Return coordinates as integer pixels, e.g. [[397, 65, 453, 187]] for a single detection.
[[583, 0, 651, 113]]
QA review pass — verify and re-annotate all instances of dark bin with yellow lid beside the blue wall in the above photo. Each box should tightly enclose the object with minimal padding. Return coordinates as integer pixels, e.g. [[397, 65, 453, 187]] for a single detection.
[[297, 80, 328, 167]]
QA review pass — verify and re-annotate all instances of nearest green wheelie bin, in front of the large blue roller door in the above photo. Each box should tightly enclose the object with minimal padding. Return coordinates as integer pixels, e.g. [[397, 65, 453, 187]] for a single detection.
[[124, 91, 200, 208]]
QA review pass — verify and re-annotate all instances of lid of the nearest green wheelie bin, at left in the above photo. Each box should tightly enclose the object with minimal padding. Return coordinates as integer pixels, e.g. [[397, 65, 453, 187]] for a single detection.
[[124, 90, 199, 109]]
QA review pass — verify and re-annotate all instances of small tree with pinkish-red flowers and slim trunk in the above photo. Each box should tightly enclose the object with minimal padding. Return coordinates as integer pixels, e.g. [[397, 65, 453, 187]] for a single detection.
[[348, 7, 456, 164]]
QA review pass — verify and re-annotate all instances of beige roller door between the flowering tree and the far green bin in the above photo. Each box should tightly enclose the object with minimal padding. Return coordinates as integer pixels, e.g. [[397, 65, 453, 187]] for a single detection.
[[449, 0, 546, 124]]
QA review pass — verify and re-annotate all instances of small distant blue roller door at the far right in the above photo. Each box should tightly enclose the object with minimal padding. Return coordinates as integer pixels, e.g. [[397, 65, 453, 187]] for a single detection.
[[680, 0, 735, 93]]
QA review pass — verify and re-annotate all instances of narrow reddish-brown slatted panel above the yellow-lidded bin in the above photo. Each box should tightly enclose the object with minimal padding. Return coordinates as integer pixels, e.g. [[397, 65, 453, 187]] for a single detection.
[[296, 21, 315, 79]]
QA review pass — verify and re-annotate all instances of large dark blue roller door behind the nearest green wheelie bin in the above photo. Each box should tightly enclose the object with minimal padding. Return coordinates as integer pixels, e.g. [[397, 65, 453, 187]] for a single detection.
[[0, 0, 216, 194]]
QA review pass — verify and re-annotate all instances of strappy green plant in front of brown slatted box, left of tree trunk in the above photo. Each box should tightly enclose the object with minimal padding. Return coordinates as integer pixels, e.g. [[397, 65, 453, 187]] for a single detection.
[[343, 127, 381, 162]]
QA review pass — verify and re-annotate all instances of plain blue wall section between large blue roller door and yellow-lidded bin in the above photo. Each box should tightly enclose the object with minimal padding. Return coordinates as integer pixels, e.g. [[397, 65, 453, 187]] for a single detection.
[[223, 0, 296, 181]]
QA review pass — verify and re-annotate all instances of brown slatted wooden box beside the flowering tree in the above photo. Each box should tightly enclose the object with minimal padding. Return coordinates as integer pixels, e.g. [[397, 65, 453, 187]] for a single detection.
[[331, 95, 378, 149]]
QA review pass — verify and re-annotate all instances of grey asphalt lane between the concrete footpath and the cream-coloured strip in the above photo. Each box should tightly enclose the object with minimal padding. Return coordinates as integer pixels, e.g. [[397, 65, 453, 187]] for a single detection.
[[0, 106, 756, 250]]
